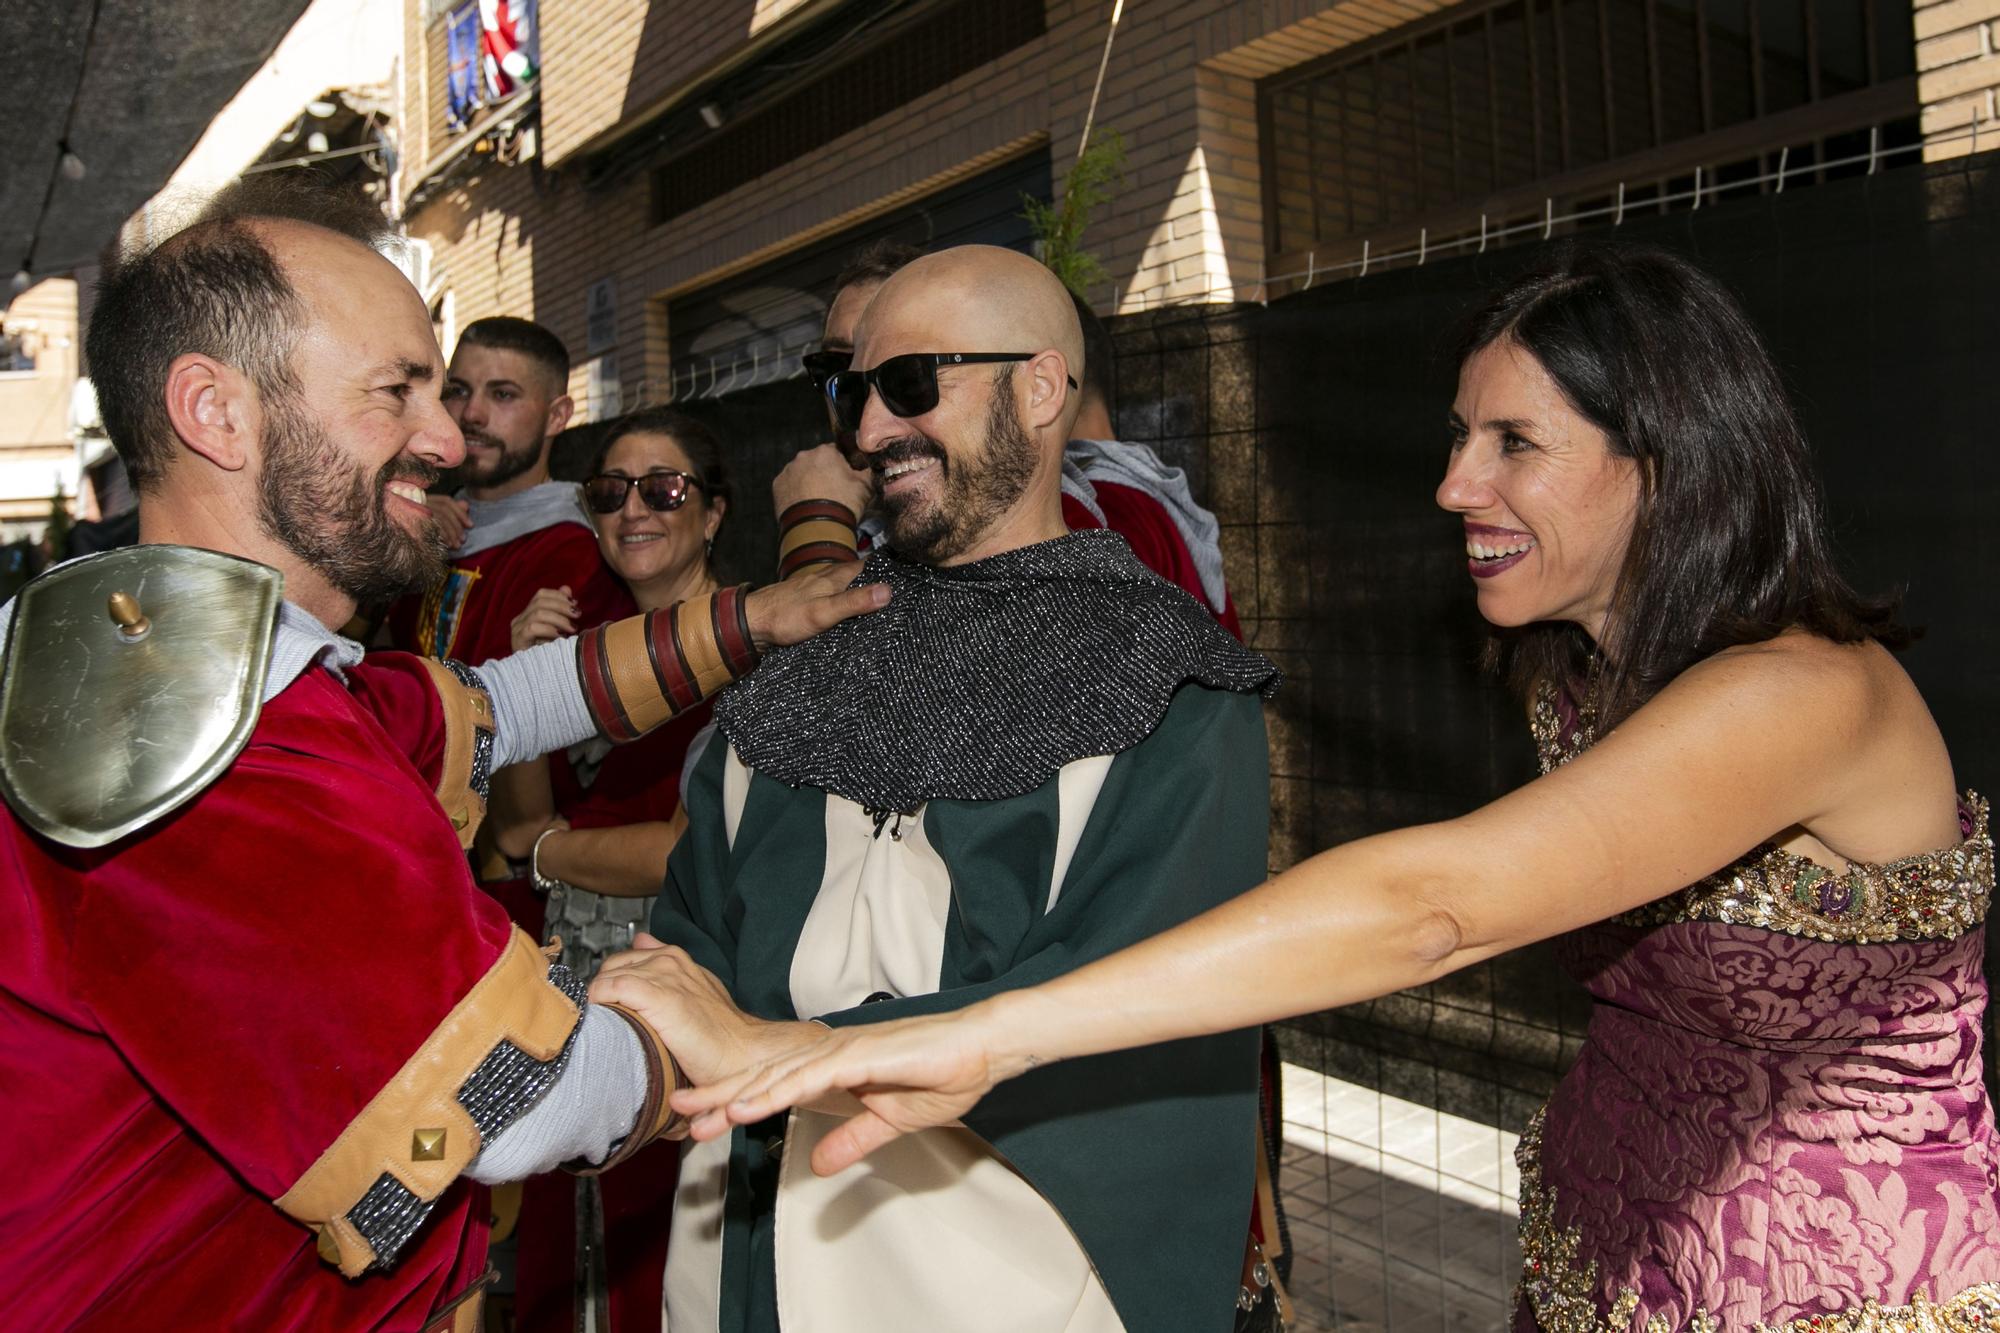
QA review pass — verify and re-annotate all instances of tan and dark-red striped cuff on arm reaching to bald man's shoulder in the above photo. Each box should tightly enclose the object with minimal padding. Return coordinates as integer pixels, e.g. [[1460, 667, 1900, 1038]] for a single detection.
[[576, 586, 758, 743]]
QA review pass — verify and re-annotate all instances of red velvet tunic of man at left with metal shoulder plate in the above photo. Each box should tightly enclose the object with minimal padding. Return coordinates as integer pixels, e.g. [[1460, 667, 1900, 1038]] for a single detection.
[[0, 654, 524, 1331]]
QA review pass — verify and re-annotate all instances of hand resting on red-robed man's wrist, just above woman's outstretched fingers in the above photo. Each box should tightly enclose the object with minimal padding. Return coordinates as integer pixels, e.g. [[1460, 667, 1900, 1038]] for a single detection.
[[590, 933, 826, 1083]]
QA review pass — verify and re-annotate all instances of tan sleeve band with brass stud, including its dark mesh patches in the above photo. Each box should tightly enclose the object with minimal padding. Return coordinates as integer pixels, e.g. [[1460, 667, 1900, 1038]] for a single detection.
[[278, 929, 584, 1277]]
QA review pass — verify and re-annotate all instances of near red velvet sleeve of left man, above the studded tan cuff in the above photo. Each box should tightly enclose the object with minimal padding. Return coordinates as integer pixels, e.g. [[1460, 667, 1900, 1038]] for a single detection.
[[74, 671, 510, 1197]]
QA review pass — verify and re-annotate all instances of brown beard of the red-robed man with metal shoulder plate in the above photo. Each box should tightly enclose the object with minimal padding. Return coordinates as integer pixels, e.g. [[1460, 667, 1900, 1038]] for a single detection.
[[258, 402, 446, 604]]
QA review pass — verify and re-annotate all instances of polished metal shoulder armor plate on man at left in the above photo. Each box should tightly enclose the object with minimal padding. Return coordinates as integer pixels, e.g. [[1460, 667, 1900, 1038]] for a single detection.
[[0, 546, 284, 847]]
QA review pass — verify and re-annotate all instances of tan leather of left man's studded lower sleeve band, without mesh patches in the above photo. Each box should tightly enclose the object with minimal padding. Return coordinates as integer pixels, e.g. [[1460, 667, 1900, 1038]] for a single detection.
[[278, 927, 580, 1277]]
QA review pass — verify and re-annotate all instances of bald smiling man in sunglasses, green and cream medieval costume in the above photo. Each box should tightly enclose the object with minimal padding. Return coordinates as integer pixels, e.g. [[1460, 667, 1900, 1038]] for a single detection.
[[594, 246, 1276, 1333]]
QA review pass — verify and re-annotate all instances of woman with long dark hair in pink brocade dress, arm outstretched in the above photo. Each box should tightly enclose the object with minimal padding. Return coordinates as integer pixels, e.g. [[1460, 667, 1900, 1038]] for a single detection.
[[632, 246, 2000, 1333]]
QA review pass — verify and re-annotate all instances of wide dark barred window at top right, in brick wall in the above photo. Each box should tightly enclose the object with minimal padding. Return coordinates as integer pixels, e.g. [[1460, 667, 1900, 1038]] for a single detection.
[[1258, 0, 1916, 272]]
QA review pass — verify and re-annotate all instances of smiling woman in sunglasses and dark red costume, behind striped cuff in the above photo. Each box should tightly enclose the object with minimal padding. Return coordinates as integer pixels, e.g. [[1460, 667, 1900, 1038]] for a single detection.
[[504, 408, 730, 1333]]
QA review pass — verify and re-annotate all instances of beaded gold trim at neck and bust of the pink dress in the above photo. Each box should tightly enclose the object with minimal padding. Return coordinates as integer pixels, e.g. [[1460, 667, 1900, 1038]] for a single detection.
[[1530, 685, 1994, 945]]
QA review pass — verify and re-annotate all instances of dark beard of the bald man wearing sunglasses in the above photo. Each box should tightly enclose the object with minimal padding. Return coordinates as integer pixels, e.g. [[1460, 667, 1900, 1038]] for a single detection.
[[872, 376, 1040, 564]]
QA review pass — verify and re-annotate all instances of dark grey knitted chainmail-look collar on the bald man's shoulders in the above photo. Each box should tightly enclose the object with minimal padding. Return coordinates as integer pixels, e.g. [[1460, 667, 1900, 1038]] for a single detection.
[[716, 528, 1278, 811]]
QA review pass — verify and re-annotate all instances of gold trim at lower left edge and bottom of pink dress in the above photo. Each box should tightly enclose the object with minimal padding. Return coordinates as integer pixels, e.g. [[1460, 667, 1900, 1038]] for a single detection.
[[1514, 1111, 2000, 1333]]
